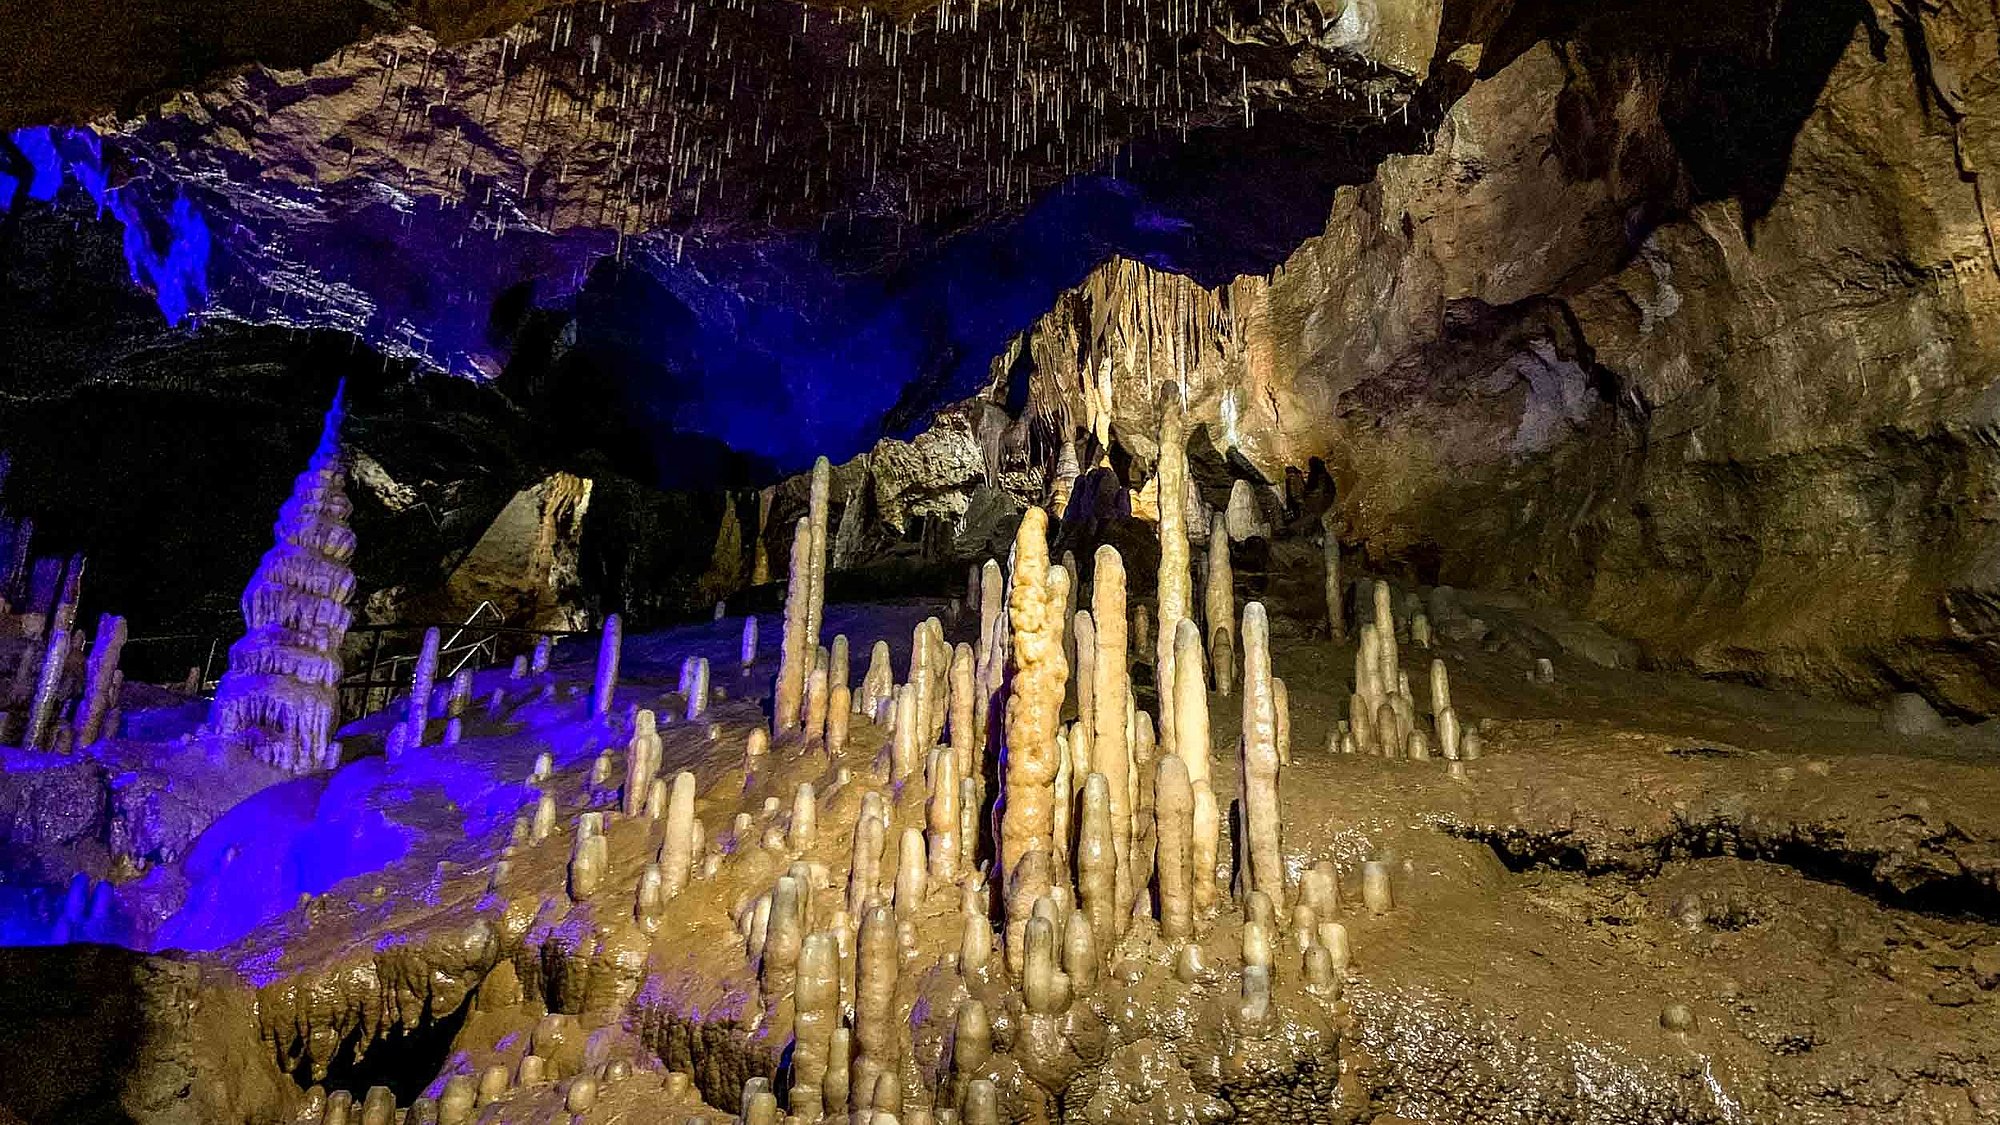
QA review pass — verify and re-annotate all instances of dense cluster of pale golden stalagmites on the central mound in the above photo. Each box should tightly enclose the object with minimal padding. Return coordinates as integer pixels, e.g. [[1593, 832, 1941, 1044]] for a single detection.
[[296, 460, 1504, 1125]]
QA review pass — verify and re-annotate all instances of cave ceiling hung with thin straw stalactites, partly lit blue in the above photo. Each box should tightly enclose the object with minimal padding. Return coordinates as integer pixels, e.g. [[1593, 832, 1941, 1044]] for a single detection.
[[0, 0, 1816, 464]]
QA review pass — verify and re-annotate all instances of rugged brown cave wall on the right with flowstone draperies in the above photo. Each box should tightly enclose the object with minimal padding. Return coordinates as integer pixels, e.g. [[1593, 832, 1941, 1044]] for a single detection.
[[932, 2, 2000, 715]]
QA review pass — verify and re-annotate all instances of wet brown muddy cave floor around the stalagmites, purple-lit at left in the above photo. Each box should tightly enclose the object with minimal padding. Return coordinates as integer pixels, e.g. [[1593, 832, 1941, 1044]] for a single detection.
[[23, 601, 2000, 1123]]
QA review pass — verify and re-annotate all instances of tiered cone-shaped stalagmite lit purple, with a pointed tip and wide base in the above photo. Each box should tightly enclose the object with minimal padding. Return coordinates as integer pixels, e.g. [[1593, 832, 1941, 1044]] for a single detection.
[[208, 376, 354, 773]]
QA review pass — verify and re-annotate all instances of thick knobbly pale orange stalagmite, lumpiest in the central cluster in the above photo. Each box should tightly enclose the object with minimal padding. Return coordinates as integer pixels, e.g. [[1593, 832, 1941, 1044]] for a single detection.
[[1000, 508, 1068, 916]]
